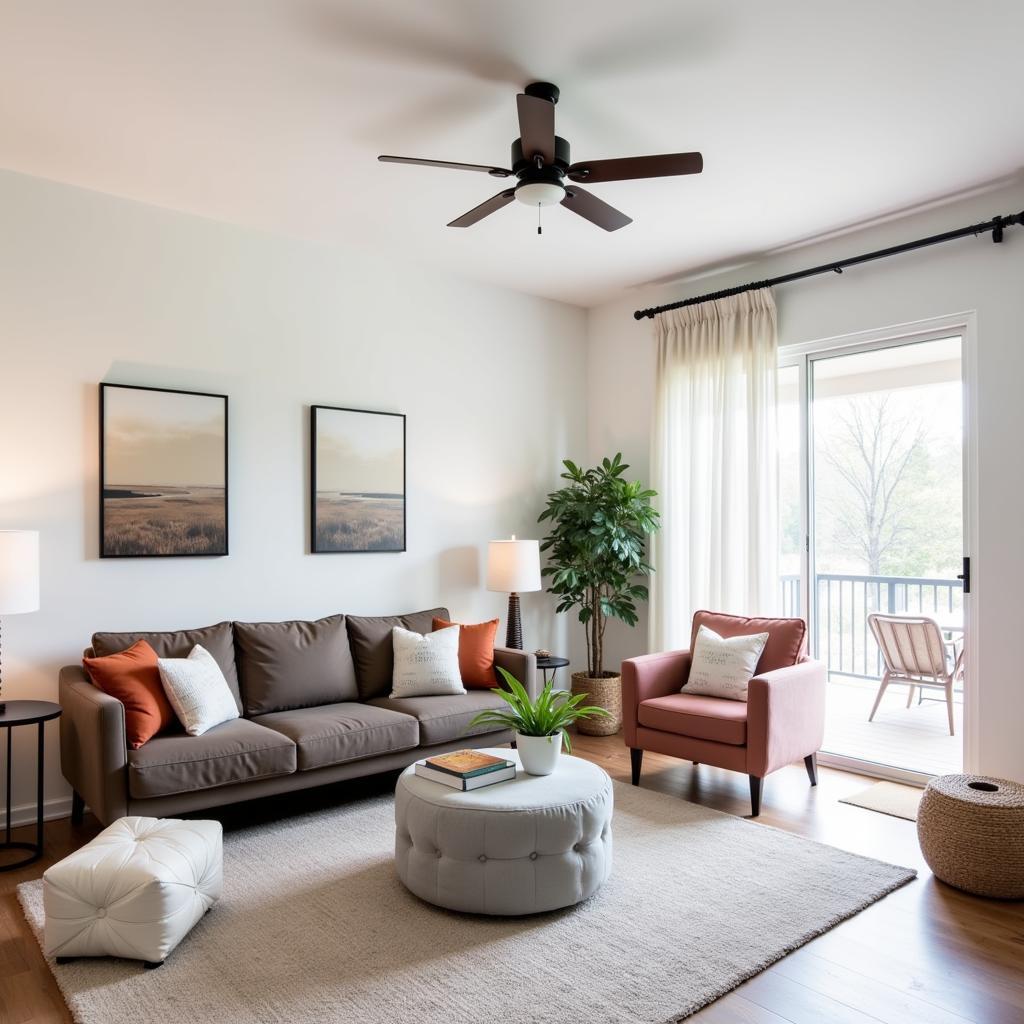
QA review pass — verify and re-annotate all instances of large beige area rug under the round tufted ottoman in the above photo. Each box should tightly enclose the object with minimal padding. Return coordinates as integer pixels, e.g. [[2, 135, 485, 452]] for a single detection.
[[18, 783, 915, 1024]]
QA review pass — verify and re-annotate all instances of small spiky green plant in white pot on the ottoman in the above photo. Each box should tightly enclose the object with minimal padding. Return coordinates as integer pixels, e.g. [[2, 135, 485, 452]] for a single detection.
[[469, 668, 608, 775]]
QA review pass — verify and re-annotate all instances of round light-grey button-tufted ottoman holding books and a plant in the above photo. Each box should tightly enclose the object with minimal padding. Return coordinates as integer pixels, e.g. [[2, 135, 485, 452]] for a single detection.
[[394, 750, 612, 915]]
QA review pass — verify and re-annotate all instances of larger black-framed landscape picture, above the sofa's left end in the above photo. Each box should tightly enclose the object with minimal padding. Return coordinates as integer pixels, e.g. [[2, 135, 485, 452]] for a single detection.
[[99, 384, 227, 558]]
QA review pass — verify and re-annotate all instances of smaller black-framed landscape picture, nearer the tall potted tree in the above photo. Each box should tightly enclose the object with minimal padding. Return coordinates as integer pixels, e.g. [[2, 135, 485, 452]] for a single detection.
[[310, 406, 406, 554]]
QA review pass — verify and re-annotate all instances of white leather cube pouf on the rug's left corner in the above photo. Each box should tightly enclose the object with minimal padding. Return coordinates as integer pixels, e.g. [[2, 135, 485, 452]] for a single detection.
[[43, 817, 223, 967]]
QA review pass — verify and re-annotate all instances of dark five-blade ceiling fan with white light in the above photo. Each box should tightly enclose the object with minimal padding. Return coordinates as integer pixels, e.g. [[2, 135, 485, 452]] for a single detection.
[[377, 82, 703, 233]]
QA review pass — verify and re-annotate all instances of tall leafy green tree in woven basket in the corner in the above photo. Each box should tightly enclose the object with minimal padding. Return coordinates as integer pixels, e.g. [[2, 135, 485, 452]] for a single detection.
[[538, 453, 659, 735]]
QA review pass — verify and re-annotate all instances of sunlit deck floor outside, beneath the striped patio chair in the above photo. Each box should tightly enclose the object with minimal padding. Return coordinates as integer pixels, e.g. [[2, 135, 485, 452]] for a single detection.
[[822, 676, 964, 775]]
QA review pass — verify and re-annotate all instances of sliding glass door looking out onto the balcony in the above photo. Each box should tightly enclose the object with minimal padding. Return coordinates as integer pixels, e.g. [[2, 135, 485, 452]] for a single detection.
[[779, 333, 970, 778]]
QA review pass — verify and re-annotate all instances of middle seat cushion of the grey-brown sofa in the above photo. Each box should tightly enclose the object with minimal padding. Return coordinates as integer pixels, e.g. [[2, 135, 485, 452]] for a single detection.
[[254, 702, 420, 771]]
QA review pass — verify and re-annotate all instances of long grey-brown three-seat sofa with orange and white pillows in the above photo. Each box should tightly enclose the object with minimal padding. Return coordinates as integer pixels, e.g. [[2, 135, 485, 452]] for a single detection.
[[59, 608, 538, 824]]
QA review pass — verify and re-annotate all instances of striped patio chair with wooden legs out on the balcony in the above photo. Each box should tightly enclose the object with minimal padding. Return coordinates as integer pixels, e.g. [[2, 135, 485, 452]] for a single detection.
[[867, 612, 964, 736]]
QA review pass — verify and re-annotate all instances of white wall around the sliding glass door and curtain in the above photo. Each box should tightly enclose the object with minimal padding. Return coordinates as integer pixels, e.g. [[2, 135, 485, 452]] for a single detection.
[[588, 186, 1024, 779]]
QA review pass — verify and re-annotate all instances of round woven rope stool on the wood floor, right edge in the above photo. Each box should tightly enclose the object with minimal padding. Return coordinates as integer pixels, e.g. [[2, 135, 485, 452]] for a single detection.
[[918, 775, 1024, 899]]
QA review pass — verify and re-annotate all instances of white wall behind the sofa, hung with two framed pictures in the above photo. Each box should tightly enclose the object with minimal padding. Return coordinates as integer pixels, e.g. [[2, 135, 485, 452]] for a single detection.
[[0, 173, 586, 812]]
